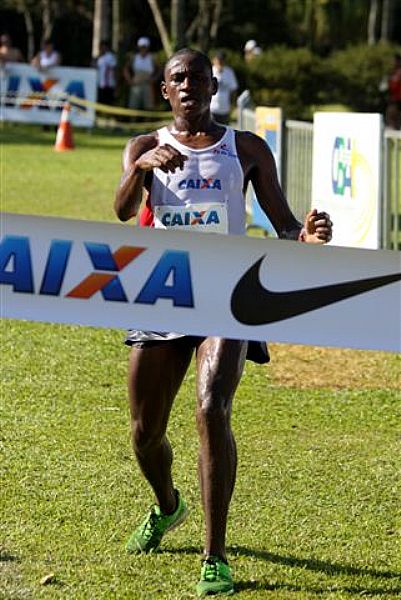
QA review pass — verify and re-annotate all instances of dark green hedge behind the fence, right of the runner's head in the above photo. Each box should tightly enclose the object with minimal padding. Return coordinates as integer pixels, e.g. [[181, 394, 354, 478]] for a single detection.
[[227, 44, 396, 119]]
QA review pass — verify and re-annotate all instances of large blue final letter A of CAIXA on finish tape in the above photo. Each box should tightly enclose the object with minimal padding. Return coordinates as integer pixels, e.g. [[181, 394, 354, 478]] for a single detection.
[[135, 250, 194, 308]]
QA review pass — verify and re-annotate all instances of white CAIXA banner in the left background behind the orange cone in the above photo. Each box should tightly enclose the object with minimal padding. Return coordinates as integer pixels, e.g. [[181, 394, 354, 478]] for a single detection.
[[0, 63, 97, 127]]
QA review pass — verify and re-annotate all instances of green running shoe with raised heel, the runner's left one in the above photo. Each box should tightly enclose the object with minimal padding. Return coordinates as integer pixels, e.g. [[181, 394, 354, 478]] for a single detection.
[[126, 490, 188, 554]]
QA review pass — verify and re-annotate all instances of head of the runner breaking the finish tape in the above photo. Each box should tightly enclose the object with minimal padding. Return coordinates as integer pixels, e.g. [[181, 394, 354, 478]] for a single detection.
[[162, 54, 216, 117]]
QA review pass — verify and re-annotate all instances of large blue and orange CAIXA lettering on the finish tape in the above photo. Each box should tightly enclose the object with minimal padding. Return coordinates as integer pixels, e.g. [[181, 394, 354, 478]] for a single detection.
[[0, 235, 194, 308]]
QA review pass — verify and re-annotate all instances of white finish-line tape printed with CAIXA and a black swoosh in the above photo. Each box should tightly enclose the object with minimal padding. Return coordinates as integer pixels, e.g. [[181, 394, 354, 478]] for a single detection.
[[0, 213, 401, 351]]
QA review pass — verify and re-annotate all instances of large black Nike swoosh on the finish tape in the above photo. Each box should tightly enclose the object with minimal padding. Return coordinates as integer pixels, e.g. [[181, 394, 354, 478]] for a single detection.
[[231, 256, 401, 325]]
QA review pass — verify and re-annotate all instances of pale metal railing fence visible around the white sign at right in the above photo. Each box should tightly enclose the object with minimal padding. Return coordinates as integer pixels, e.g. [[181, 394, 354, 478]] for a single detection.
[[238, 107, 401, 250]]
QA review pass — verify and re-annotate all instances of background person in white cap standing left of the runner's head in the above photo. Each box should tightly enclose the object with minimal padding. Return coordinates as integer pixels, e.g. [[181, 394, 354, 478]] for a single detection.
[[124, 36, 157, 110]]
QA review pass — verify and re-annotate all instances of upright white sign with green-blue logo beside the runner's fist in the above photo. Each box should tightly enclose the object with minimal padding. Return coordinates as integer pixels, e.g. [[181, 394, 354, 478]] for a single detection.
[[312, 112, 382, 248]]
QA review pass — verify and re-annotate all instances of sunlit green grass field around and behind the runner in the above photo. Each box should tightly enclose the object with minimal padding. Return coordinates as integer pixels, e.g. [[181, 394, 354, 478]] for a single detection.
[[0, 126, 401, 600]]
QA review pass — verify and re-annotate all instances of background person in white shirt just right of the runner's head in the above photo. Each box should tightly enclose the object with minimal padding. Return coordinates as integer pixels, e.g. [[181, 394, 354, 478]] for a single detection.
[[210, 51, 238, 125]]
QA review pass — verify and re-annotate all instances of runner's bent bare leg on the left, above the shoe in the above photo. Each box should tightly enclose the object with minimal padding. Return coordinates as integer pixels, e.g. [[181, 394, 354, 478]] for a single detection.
[[128, 341, 192, 514]]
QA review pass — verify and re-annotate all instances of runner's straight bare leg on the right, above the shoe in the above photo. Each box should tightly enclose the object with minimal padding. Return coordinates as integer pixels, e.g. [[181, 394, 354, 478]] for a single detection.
[[196, 338, 247, 559]]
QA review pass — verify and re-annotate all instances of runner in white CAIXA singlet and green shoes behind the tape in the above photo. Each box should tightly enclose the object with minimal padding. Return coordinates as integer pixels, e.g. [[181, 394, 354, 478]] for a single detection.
[[115, 49, 332, 597]]
